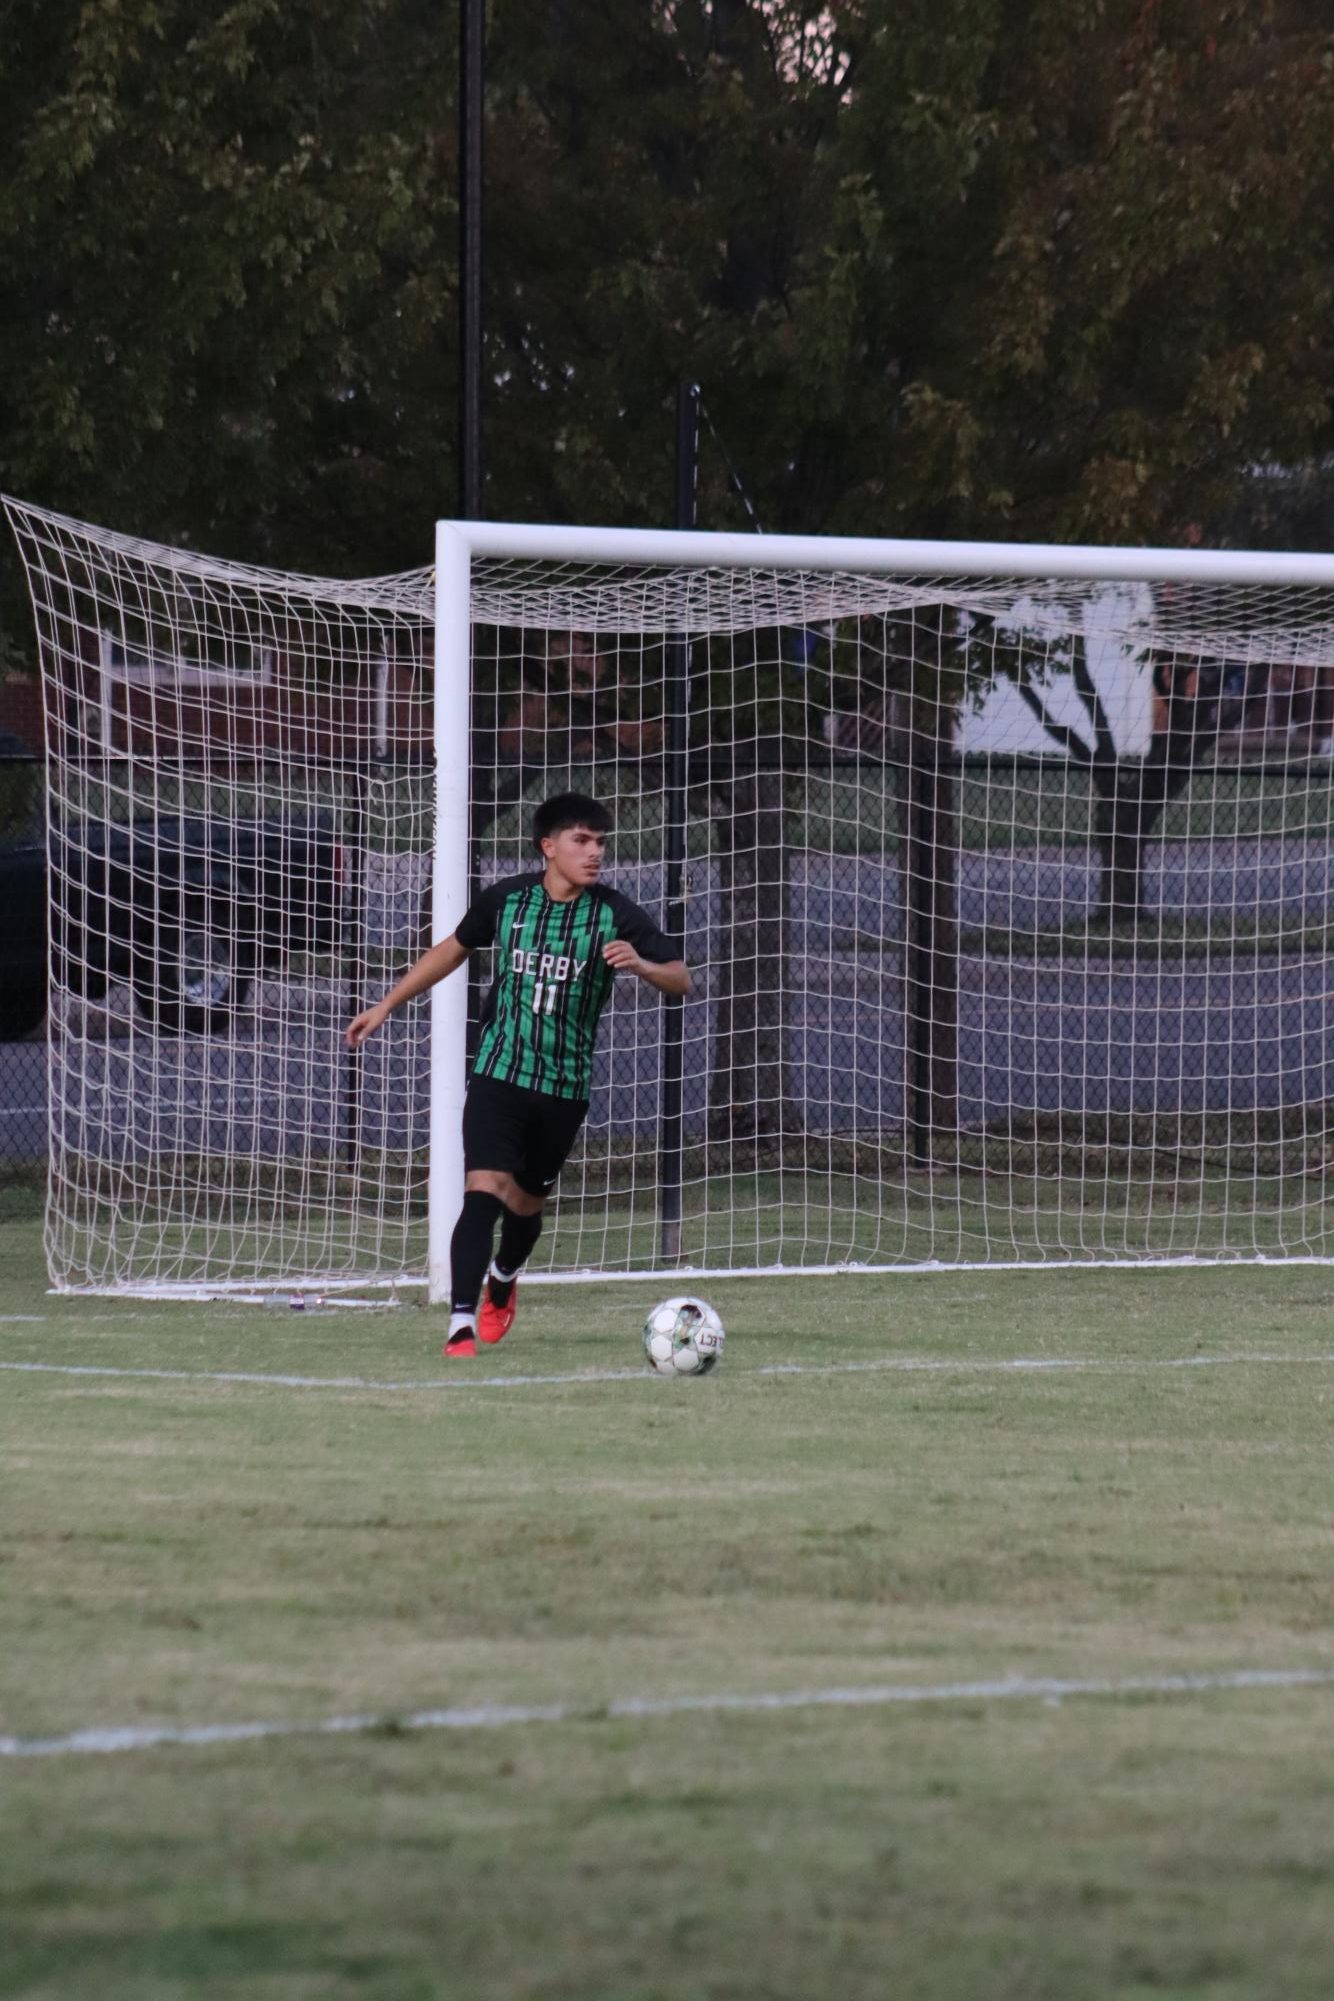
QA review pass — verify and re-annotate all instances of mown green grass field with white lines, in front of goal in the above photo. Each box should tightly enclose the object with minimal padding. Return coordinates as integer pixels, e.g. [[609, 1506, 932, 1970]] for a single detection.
[[0, 1215, 1334, 2001]]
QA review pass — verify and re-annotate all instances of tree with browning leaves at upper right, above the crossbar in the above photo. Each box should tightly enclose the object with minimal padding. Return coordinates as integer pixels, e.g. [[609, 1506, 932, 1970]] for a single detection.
[[846, 0, 1334, 542]]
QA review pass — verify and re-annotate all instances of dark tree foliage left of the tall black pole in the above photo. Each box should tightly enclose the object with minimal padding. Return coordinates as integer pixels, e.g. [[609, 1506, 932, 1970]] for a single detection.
[[0, 0, 454, 664]]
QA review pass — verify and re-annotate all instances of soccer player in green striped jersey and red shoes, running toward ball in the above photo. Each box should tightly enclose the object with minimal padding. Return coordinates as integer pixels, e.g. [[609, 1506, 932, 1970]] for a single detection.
[[348, 792, 690, 1357]]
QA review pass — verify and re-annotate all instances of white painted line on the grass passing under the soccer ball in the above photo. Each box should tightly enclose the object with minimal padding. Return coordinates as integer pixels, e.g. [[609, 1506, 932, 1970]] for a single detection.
[[0, 1353, 1334, 1393]]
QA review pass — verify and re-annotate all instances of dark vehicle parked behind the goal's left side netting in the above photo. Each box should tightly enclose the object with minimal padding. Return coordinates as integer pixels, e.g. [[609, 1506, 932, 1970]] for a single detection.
[[0, 816, 344, 1039]]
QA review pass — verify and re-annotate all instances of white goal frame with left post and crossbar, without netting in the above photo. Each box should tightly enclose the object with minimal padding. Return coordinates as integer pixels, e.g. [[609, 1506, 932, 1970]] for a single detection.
[[428, 520, 1334, 1303]]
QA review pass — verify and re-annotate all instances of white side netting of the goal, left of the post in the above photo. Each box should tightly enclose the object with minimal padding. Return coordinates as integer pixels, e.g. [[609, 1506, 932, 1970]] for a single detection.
[[8, 502, 434, 1293]]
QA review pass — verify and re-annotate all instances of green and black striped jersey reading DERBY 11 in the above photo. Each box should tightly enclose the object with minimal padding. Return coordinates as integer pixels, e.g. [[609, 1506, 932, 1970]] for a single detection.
[[456, 876, 680, 1099]]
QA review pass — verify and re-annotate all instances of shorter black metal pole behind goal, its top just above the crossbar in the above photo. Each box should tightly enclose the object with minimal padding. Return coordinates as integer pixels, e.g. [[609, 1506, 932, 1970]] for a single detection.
[[658, 382, 700, 1259]]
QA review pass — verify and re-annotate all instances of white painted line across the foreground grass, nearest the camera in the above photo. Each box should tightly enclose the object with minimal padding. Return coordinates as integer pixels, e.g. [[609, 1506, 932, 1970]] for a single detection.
[[0, 1667, 1334, 1757]]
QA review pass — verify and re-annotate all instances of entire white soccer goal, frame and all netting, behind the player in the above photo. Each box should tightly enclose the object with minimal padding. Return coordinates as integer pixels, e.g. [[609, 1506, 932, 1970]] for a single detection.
[[10, 492, 1334, 1297]]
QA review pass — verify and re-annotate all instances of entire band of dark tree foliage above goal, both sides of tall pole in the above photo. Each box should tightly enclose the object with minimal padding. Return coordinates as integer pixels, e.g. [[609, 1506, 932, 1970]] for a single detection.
[[0, 0, 1334, 680]]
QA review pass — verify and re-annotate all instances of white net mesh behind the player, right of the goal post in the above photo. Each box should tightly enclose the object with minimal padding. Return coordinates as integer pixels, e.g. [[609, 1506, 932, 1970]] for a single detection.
[[472, 562, 1334, 1271]]
